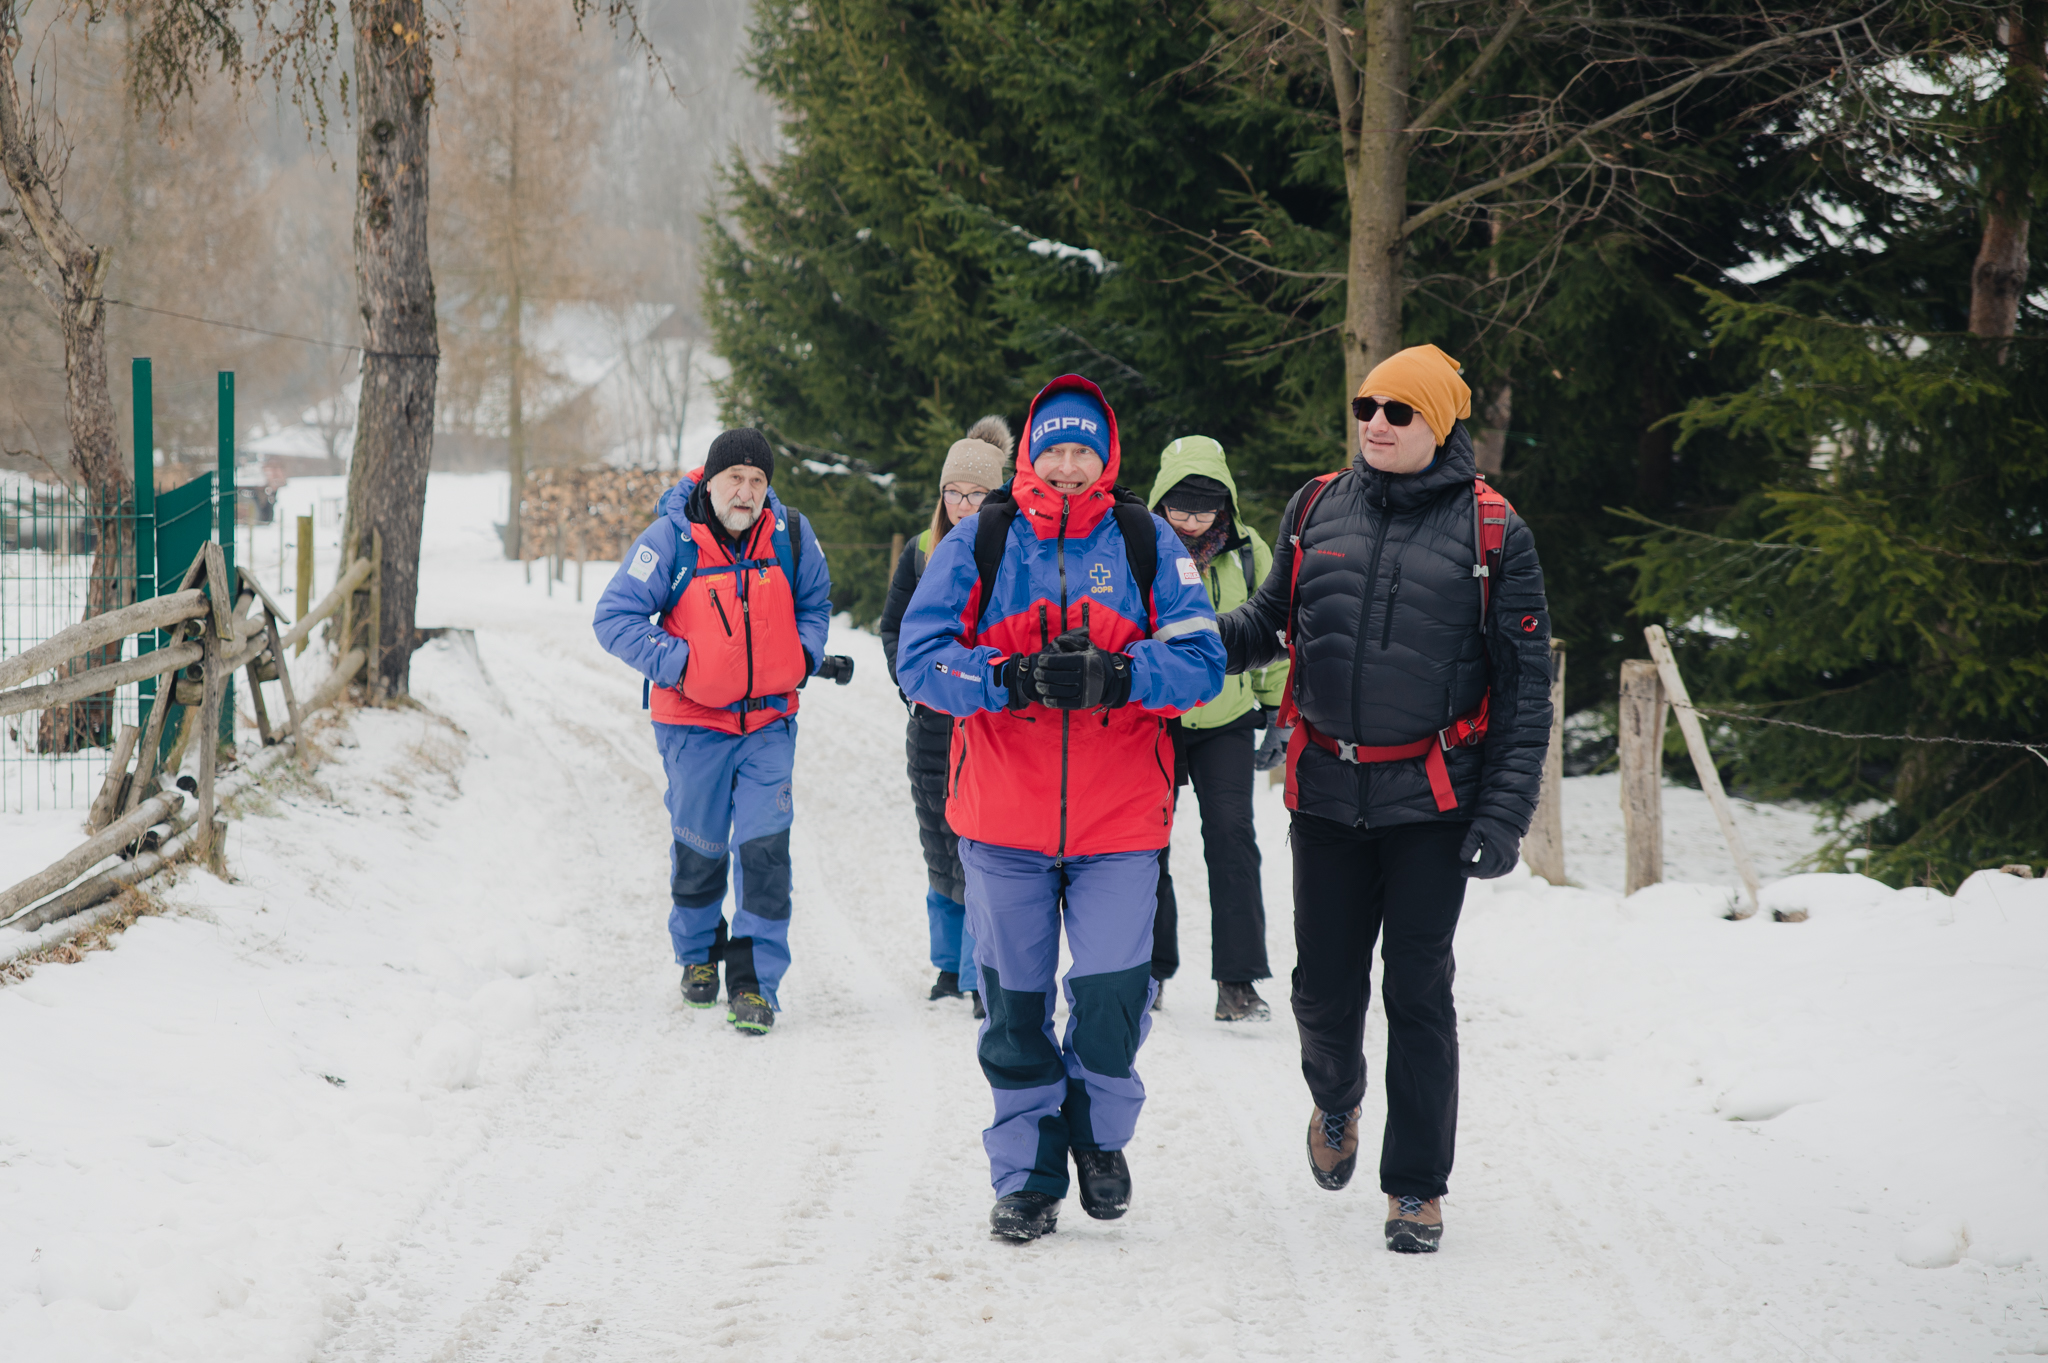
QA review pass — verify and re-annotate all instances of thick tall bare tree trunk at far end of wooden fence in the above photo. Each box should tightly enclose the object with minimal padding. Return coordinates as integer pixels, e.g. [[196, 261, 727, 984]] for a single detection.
[[340, 0, 440, 694]]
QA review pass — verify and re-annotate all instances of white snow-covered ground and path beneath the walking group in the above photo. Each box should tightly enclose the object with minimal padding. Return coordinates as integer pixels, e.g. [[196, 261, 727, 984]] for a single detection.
[[0, 475, 2048, 1363]]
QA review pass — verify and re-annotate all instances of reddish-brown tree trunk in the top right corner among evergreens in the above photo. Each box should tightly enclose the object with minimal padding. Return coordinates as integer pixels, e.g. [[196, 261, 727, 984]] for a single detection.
[[1970, 0, 2048, 349]]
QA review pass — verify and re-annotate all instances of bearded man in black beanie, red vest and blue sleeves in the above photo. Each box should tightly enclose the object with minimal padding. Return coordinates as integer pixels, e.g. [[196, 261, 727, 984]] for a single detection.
[[594, 430, 852, 1036]]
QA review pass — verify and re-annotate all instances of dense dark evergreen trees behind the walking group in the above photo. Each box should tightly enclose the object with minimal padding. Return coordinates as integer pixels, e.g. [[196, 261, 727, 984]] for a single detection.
[[707, 0, 2048, 882]]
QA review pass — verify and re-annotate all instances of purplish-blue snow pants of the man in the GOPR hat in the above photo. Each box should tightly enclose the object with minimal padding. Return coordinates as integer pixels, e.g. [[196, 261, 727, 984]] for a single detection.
[[961, 837, 1159, 1197]]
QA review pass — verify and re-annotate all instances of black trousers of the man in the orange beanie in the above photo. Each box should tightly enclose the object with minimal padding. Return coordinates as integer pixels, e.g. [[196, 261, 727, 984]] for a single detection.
[[1288, 812, 1470, 1197]]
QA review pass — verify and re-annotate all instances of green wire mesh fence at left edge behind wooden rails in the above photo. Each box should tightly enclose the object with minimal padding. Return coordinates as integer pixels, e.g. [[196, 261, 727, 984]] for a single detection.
[[0, 473, 139, 812]]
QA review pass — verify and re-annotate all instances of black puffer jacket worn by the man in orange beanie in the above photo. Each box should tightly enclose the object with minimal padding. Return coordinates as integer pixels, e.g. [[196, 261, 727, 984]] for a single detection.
[[1221, 424, 1550, 831]]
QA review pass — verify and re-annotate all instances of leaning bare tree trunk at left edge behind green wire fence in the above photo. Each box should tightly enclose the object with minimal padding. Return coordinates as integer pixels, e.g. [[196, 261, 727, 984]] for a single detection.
[[0, 0, 133, 753]]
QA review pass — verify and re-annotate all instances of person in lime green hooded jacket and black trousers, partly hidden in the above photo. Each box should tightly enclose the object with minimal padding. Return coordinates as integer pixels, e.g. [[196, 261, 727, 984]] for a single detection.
[[1147, 436, 1286, 1021]]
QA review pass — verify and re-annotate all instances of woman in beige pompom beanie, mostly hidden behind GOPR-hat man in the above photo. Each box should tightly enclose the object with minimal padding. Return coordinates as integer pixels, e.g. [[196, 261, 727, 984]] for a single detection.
[[881, 415, 1012, 1017]]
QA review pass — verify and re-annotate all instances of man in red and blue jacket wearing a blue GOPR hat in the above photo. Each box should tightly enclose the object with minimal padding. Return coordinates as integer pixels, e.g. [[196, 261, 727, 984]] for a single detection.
[[897, 375, 1223, 1240]]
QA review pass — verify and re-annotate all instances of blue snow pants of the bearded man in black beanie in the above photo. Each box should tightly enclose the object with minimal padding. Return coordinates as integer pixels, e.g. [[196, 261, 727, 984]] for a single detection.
[[653, 718, 797, 1009]]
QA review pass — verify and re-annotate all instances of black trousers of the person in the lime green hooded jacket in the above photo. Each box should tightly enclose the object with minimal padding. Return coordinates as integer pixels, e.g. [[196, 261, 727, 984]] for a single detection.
[[1153, 724, 1272, 984]]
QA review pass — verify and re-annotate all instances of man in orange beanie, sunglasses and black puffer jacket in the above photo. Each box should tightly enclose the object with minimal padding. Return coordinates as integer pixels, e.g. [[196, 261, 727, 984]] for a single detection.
[[1221, 346, 1550, 1252]]
